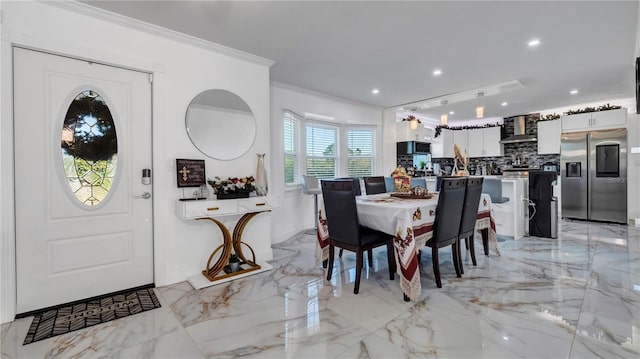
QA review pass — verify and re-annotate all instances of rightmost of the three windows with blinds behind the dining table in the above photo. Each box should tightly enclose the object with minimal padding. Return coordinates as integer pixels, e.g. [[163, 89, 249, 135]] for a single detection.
[[347, 128, 375, 177]]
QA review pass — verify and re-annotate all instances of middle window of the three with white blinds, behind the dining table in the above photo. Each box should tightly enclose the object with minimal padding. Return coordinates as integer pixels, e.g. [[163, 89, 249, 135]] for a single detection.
[[306, 123, 338, 178]]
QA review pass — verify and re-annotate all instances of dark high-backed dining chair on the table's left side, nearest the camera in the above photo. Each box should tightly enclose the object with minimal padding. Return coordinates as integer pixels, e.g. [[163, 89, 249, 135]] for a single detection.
[[321, 180, 396, 294]]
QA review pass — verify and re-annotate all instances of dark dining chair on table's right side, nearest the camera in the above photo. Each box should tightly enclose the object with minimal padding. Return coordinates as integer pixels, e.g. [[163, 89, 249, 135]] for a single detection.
[[426, 177, 467, 288]]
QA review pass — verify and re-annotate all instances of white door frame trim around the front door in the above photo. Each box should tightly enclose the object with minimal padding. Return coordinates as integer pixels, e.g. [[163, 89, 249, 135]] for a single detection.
[[0, 38, 164, 323]]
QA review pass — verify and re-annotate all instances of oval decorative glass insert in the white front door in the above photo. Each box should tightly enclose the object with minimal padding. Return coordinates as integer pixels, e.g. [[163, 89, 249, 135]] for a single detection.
[[61, 90, 118, 206]]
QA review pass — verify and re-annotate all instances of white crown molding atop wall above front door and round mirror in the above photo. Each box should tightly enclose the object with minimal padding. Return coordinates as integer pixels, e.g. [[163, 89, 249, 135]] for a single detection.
[[45, 0, 275, 67]]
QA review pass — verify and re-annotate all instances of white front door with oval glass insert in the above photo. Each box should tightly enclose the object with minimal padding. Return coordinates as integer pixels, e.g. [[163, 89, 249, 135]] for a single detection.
[[13, 48, 153, 313]]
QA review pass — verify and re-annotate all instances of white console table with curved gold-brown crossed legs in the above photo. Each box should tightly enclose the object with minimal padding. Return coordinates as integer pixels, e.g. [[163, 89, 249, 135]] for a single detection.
[[175, 196, 280, 289]]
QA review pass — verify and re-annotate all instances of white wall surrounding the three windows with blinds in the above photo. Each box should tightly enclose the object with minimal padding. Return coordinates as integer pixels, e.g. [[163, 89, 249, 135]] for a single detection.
[[267, 83, 382, 243]]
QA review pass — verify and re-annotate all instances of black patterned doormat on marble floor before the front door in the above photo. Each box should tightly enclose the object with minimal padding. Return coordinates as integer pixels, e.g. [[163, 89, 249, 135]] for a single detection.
[[23, 288, 160, 345]]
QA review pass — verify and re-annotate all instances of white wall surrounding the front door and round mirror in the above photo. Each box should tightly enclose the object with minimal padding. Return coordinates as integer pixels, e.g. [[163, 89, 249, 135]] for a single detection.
[[0, 2, 273, 322]]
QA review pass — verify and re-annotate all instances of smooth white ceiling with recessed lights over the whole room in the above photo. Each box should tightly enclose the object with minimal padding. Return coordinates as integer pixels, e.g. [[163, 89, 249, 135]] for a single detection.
[[85, 0, 638, 124]]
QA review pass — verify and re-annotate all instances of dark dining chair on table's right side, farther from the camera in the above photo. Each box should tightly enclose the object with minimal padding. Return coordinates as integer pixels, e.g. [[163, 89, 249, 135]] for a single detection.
[[458, 177, 484, 274]]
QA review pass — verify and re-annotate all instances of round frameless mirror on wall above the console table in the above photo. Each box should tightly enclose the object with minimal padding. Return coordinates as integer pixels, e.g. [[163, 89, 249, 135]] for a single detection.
[[185, 90, 256, 160]]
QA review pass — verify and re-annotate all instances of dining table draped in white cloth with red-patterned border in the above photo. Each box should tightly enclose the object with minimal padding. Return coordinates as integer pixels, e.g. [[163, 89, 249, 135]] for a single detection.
[[317, 192, 500, 301]]
